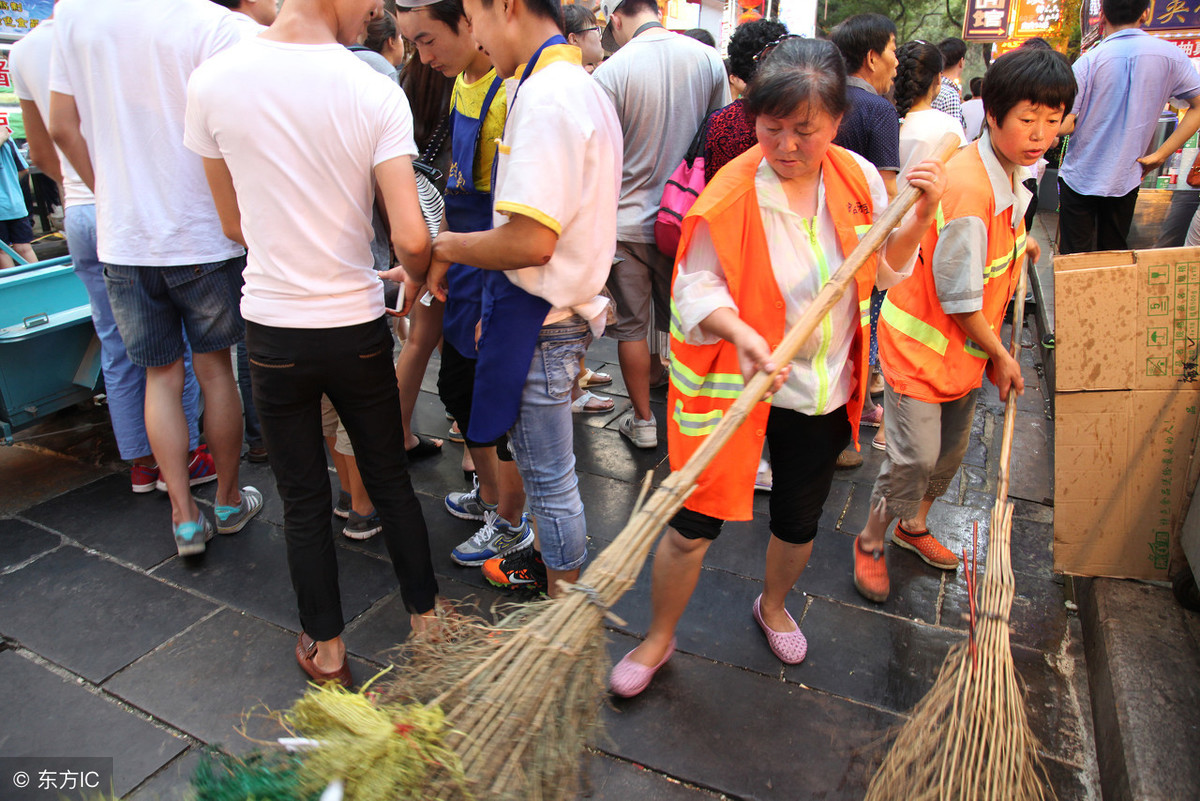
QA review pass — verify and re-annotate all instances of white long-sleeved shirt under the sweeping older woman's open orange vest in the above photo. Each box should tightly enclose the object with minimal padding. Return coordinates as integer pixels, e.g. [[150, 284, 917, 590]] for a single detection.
[[671, 151, 917, 415]]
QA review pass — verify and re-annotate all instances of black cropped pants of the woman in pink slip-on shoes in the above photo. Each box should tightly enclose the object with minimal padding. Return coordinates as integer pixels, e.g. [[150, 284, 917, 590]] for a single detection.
[[671, 406, 850, 546]]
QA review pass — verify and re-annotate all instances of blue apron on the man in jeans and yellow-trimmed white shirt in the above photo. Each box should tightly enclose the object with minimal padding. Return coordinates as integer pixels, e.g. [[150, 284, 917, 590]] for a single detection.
[[467, 36, 566, 442]]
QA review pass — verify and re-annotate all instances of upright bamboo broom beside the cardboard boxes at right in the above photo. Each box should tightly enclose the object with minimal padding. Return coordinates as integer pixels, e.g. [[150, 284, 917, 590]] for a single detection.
[[866, 231, 1055, 801]]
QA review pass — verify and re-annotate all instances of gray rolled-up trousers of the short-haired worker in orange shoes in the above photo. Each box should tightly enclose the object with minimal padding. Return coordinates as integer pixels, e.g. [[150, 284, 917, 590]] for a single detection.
[[871, 377, 976, 519]]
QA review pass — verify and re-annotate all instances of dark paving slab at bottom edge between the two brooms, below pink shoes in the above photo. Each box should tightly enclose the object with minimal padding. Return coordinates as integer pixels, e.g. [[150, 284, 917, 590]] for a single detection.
[[601, 637, 899, 801]]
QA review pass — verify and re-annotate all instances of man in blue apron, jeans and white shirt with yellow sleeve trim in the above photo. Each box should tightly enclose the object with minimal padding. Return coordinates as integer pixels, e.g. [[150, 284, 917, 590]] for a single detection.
[[428, 0, 619, 596]]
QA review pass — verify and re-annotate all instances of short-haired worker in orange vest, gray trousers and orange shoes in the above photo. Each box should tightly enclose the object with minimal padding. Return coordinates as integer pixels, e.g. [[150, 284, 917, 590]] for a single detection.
[[854, 48, 1075, 602]]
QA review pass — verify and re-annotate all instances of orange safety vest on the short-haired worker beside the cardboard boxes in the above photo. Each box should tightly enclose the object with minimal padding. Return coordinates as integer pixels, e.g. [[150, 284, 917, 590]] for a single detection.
[[877, 141, 1025, 403]]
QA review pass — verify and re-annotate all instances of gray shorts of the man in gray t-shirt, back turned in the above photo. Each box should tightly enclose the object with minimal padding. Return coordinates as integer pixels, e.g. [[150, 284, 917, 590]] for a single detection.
[[605, 237, 674, 342]]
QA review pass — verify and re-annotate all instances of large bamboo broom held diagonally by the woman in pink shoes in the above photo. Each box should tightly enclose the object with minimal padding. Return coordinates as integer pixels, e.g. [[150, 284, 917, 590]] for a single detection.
[[328, 134, 958, 801]]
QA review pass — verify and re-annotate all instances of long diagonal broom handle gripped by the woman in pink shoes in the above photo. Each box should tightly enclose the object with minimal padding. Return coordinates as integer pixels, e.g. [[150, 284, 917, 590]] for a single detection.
[[667, 133, 959, 487]]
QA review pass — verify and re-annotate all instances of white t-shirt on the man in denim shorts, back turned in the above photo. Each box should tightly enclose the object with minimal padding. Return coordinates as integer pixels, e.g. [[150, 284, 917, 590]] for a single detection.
[[50, 0, 246, 266]]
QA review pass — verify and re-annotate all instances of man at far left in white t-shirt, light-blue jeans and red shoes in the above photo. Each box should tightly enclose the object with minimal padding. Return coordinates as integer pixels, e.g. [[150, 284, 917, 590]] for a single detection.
[[8, 6, 207, 493]]
